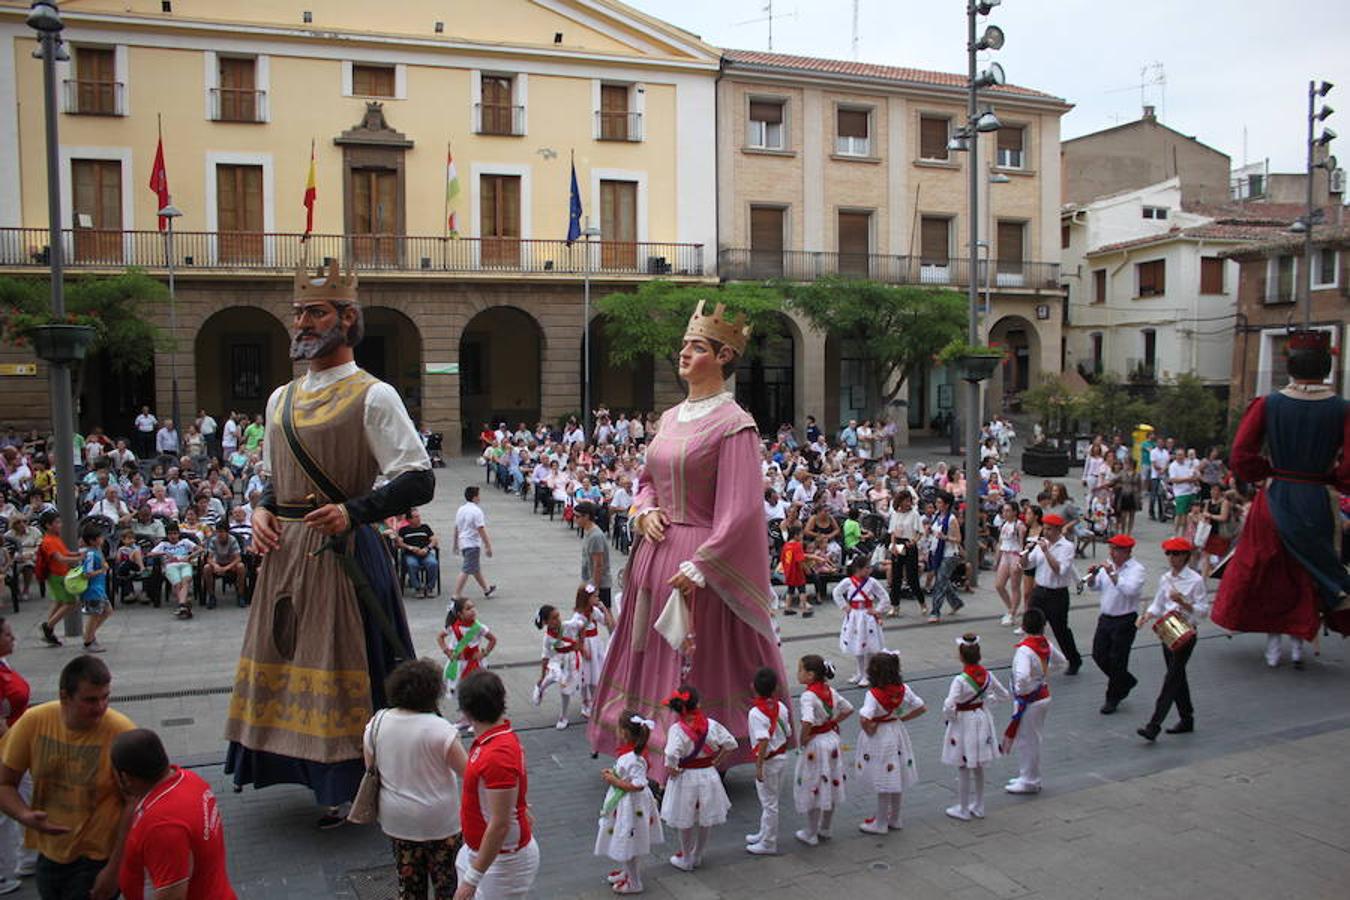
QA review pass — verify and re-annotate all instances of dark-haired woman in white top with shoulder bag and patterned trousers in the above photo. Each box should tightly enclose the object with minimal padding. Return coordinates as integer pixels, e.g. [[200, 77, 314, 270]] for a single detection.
[[359, 660, 467, 900]]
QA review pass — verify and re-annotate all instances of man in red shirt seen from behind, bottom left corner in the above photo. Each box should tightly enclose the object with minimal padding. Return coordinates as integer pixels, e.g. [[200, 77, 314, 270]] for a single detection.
[[109, 729, 235, 900]]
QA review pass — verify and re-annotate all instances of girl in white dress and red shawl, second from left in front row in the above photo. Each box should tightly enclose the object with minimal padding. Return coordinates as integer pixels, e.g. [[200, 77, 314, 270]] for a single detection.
[[662, 684, 736, 872]]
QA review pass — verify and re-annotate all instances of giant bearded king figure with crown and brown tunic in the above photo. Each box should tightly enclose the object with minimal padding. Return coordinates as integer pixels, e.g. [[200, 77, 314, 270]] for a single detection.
[[225, 260, 436, 827]]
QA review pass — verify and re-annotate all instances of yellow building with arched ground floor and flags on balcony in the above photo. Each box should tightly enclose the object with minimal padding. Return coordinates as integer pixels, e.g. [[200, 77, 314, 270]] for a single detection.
[[0, 0, 718, 447]]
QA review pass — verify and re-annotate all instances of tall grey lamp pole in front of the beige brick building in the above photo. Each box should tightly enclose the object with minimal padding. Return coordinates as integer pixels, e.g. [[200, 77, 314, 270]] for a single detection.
[[961, 0, 980, 587]]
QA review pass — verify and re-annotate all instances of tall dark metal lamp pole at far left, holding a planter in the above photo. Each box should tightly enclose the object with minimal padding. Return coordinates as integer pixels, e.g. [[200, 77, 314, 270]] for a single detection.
[[38, 24, 80, 637]]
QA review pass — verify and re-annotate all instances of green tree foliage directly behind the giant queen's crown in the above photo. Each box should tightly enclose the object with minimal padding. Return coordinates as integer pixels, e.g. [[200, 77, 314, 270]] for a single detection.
[[597, 281, 783, 372]]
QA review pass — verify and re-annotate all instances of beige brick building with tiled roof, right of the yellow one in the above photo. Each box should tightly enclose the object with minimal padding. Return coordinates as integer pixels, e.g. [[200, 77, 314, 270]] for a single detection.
[[717, 50, 1069, 437]]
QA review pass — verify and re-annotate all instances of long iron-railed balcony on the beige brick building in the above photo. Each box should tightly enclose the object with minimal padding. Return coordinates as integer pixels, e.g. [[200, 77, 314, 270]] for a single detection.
[[718, 248, 1060, 291]]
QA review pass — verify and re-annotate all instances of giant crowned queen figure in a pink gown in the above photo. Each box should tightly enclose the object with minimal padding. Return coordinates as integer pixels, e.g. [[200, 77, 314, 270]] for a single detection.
[[587, 302, 788, 780]]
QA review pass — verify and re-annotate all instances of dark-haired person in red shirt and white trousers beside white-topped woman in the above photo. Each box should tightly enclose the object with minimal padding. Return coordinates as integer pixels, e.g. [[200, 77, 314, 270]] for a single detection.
[[455, 669, 539, 900]]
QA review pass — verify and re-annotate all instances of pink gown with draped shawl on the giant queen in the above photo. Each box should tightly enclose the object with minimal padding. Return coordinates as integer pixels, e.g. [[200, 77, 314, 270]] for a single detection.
[[586, 399, 787, 780]]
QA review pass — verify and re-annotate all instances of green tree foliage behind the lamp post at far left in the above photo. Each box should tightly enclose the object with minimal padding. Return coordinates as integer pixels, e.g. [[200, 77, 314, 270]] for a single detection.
[[0, 269, 169, 375]]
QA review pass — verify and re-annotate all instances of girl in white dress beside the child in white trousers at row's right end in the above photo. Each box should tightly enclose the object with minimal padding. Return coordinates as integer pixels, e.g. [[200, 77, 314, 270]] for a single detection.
[[942, 633, 1008, 820]]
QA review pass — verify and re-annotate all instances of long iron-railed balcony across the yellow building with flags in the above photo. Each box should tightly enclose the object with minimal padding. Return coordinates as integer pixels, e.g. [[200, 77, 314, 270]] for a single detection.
[[0, 228, 710, 279]]
